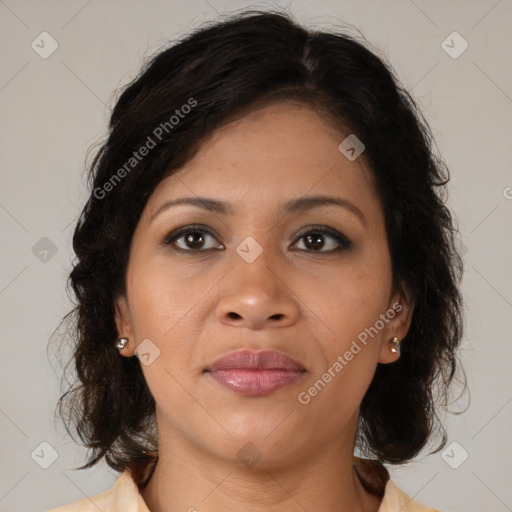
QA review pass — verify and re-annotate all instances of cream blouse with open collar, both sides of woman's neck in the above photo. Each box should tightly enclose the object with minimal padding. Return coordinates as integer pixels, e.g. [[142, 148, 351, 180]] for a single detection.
[[48, 457, 441, 512]]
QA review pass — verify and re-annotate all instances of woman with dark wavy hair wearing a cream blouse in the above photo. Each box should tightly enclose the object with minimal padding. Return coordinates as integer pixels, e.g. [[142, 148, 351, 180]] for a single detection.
[[48, 11, 462, 512]]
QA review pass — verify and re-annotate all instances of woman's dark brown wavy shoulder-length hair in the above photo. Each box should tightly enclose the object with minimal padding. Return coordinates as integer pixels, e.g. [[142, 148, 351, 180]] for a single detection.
[[49, 11, 466, 480]]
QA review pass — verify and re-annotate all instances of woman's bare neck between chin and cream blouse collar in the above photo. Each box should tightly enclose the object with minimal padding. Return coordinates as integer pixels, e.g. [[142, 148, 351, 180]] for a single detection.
[[141, 428, 382, 512]]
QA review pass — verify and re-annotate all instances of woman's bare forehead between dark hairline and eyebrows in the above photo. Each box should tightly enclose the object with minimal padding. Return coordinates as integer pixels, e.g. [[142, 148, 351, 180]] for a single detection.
[[144, 102, 377, 218]]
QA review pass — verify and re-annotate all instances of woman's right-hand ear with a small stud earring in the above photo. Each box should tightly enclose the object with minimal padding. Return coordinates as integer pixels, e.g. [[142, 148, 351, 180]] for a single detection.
[[379, 291, 414, 364]]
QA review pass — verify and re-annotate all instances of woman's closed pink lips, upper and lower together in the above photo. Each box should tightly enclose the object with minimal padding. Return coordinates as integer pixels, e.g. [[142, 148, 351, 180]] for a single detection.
[[205, 350, 307, 396]]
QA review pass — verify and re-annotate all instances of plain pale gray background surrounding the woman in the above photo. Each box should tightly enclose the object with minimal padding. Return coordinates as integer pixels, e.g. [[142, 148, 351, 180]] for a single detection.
[[0, 0, 512, 512]]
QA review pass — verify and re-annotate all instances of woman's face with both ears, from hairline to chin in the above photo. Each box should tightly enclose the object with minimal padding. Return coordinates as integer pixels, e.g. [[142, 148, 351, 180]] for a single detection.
[[116, 102, 411, 466]]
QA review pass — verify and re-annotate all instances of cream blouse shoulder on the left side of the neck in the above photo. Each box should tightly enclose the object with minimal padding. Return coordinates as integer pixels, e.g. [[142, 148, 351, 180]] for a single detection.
[[47, 470, 149, 512]]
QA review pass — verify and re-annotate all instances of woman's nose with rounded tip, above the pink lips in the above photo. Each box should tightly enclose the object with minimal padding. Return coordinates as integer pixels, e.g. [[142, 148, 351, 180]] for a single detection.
[[217, 256, 300, 330]]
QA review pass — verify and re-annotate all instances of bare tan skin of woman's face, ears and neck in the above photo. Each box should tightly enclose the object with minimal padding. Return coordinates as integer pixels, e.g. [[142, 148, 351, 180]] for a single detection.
[[116, 102, 412, 512]]
